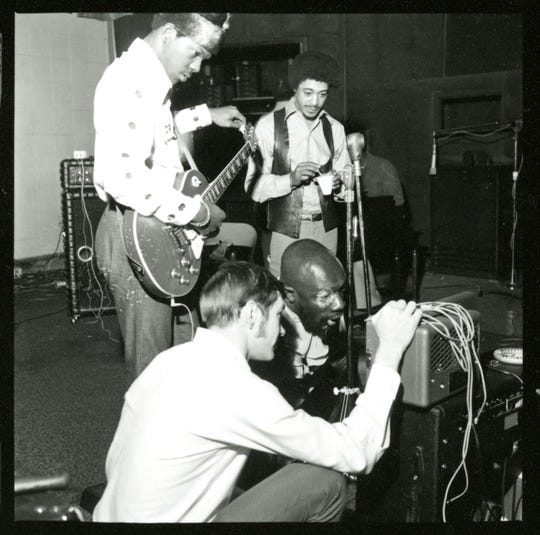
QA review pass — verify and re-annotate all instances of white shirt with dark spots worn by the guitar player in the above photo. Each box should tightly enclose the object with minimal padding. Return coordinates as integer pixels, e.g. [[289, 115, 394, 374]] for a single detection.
[[94, 39, 211, 225]]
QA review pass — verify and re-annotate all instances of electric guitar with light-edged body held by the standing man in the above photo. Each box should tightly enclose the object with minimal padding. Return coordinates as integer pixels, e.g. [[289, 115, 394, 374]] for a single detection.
[[123, 124, 257, 299]]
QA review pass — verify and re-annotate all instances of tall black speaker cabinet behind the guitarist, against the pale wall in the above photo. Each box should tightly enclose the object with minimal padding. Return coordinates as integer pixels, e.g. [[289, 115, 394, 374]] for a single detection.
[[60, 158, 114, 322]]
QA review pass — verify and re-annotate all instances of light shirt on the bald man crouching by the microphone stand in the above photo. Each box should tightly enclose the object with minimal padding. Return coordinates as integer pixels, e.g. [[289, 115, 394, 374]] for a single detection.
[[281, 306, 328, 378]]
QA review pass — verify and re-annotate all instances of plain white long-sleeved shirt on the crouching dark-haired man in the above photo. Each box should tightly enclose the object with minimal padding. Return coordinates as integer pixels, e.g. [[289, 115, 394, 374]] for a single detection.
[[93, 328, 400, 523]]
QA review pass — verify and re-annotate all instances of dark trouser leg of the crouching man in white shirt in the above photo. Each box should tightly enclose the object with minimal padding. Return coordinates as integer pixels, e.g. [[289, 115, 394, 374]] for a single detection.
[[214, 463, 346, 522]]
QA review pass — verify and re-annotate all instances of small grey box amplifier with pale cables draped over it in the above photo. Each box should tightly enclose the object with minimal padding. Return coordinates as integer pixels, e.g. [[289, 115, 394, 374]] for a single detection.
[[366, 310, 480, 407]]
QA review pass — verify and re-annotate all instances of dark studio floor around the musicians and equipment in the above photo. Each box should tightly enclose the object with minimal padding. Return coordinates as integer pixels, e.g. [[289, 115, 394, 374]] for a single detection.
[[14, 271, 522, 520]]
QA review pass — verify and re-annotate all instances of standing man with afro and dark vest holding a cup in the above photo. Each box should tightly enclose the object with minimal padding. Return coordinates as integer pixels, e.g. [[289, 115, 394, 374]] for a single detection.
[[245, 51, 350, 276]]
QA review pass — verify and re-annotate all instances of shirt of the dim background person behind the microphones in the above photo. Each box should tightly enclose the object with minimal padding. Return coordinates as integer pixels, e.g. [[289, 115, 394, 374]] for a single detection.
[[361, 151, 405, 206]]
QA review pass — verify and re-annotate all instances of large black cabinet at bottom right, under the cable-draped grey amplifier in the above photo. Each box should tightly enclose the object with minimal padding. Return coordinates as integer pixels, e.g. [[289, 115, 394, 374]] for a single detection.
[[357, 370, 523, 522]]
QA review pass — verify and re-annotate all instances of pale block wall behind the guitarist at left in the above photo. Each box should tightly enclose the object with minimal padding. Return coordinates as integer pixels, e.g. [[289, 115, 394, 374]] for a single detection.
[[14, 13, 109, 260]]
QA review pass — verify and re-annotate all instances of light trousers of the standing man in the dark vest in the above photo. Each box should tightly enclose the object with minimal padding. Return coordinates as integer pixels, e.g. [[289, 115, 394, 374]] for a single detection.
[[263, 221, 337, 277]]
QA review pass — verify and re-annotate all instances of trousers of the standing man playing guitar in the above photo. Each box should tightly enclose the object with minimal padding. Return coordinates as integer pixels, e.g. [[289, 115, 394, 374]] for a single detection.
[[96, 208, 173, 385]]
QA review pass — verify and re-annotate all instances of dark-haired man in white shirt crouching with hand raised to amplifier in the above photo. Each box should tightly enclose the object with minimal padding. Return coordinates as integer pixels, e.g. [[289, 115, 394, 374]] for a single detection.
[[93, 262, 421, 523]]
